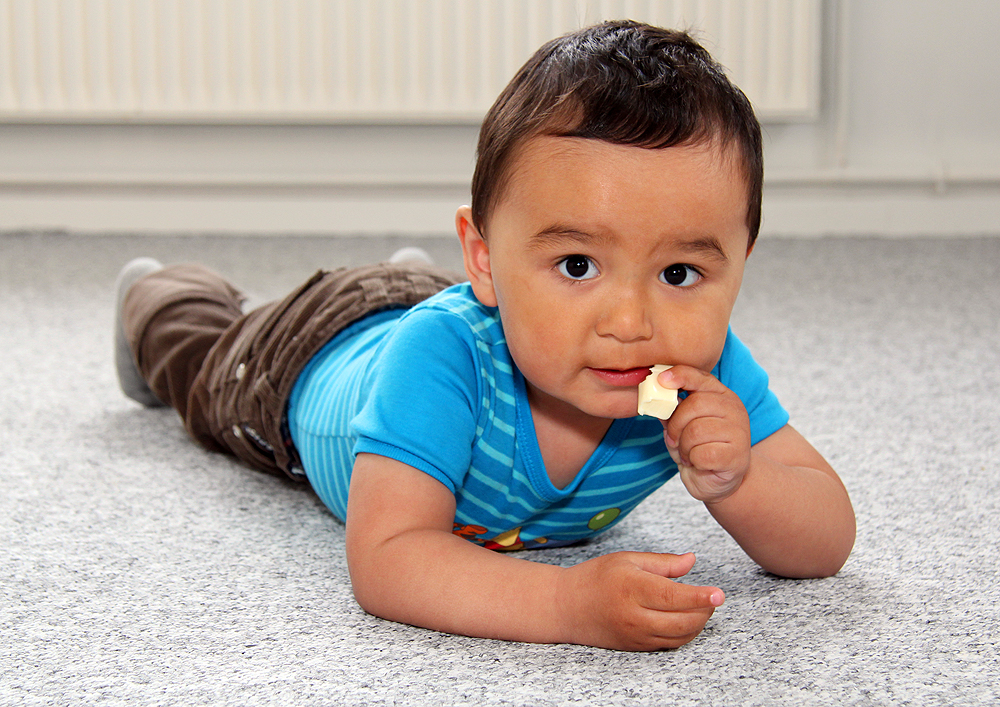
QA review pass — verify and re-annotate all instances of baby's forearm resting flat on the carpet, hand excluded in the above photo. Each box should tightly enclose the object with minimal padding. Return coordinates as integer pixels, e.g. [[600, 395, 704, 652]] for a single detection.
[[351, 530, 566, 643]]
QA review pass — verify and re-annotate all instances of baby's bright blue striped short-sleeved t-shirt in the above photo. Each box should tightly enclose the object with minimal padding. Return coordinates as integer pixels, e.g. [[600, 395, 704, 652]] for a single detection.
[[288, 283, 788, 550]]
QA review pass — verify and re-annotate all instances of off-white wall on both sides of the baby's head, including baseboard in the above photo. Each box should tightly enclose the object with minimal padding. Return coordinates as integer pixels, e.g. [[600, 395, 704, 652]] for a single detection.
[[0, 0, 1000, 235]]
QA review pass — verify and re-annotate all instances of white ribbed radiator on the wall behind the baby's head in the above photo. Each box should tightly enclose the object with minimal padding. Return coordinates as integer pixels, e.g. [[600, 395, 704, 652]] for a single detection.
[[0, 0, 821, 123]]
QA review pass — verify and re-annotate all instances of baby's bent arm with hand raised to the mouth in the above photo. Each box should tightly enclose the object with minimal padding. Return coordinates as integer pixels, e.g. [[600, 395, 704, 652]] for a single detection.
[[659, 366, 855, 577]]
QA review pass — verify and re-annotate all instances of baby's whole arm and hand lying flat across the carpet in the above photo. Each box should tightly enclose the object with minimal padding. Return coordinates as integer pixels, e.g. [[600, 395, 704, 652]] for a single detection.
[[347, 454, 723, 650]]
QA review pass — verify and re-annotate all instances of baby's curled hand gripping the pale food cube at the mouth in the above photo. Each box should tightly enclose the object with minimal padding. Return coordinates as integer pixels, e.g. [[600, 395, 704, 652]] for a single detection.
[[659, 366, 750, 504]]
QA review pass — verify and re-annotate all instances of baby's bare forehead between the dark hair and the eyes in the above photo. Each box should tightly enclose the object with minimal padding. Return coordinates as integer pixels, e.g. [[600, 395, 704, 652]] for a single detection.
[[487, 136, 749, 255]]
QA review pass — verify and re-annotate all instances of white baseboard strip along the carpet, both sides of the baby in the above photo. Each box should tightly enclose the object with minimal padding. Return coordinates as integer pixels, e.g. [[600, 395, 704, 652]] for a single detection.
[[0, 184, 1000, 237]]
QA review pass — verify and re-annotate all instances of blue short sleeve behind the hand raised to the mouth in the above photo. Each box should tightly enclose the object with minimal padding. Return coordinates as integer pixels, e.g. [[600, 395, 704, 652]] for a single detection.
[[715, 329, 789, 444]]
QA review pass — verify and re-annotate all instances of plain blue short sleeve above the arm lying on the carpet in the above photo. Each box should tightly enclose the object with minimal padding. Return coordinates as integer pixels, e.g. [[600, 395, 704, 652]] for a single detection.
[[352, 308, 481, 492]]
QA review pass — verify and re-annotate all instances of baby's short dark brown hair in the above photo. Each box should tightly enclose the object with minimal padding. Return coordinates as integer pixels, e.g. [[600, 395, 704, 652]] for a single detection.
[[472, 20, 764, 244]]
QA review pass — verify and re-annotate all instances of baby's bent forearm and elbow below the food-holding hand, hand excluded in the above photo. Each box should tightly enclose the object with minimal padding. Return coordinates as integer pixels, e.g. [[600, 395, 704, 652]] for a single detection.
[[706, 450, 855, 578]]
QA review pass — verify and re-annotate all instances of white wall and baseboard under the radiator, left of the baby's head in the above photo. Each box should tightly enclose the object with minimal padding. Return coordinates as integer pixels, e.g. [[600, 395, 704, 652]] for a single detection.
[[0, 125, 476, 234]]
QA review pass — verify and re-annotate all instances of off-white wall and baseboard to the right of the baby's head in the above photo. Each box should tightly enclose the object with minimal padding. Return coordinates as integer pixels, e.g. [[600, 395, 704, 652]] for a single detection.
[[765, 0, 1000, 235]]
